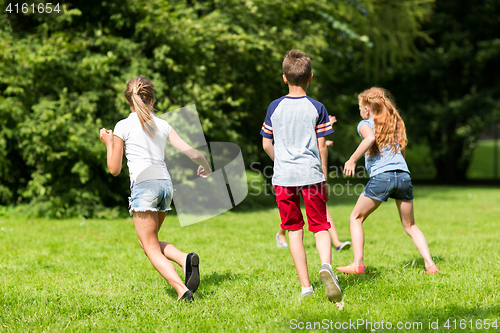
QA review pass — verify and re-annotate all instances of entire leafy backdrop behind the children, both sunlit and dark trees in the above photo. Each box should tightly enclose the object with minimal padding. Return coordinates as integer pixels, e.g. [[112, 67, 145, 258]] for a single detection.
[[0, 0, 500, 217]]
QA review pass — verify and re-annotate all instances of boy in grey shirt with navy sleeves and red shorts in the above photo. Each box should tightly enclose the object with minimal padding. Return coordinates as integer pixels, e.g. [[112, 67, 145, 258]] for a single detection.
[[260, 50, 342, 302]]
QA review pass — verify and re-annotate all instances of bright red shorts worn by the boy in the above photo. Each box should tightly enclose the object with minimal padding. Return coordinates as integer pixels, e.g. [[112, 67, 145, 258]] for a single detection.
[[274, 183, 330, 232]]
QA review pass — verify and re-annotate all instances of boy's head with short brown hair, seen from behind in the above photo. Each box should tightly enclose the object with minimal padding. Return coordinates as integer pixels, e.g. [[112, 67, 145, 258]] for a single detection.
[[283, 50, 312, 86]]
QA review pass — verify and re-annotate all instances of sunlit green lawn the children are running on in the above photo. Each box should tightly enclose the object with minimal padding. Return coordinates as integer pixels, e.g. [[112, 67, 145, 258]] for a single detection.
[[0, 186, 500, 332]]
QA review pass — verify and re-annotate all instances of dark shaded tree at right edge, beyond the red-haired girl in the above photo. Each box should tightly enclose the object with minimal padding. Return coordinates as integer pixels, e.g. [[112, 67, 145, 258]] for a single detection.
[[387, 0, 500, 182]]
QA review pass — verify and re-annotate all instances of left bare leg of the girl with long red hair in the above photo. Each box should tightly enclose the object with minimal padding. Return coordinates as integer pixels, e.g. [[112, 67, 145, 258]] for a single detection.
[[350, 194, 382, 266]]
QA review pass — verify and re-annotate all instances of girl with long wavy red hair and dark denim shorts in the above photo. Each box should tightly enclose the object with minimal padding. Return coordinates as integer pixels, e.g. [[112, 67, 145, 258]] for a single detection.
[[337, 87, 439, 274]]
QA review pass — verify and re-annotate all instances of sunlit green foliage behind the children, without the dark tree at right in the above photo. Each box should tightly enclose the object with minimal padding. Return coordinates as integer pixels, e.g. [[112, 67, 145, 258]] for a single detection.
[[0, 0, 434, 216]]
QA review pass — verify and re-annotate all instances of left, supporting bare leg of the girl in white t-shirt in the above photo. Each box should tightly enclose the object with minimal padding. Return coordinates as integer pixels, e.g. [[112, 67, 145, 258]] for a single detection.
[[134, 211, 188, 298]]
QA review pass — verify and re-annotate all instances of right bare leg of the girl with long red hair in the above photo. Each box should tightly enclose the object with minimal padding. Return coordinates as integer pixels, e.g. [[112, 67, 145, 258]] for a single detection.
[[396, 200, 434, 269]]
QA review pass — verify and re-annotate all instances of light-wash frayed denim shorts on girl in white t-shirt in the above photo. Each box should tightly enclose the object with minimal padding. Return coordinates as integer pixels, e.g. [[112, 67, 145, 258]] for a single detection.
[[128, 179, 174, 214]]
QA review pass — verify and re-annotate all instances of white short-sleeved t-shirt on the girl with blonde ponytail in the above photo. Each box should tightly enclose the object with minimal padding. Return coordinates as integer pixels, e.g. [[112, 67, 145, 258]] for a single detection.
[[113, 112, 172, 184]]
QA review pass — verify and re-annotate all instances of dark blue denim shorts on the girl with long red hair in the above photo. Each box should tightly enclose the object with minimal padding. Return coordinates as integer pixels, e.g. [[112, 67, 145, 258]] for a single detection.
[[363, 170, 413, 201]]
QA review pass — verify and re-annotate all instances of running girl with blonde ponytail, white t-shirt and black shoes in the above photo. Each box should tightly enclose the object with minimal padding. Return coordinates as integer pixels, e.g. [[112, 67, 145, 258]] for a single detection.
[[100, 77, 212, 301]]
